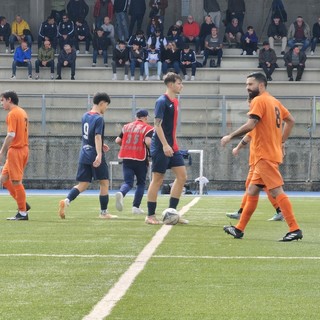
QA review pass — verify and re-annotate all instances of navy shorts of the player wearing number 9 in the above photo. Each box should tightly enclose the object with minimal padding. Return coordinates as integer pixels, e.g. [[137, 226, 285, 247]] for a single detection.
[[76, 161, 109, 182]]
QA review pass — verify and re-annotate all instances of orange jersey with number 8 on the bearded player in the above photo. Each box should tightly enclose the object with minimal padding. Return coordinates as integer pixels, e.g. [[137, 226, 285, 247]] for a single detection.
[[248, 92, 290, 163]]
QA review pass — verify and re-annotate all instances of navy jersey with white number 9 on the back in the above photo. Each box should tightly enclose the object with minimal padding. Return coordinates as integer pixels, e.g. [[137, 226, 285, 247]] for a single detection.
[[79, 111, 104, 164]]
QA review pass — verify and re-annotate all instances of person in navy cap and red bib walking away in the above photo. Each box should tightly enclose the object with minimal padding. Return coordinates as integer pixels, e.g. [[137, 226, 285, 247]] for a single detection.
[[115, 109, 153, 214]]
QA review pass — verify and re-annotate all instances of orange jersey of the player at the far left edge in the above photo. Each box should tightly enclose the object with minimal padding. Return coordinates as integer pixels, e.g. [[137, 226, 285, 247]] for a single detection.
[[6, 106, 28, 148]]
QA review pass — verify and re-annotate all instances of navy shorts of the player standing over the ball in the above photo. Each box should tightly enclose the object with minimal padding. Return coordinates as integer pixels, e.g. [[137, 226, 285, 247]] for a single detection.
[[151, 150, 185, 173]]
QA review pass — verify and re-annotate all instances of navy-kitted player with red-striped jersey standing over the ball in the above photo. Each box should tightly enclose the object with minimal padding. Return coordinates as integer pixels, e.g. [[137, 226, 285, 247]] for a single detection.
[[145, 72, 188, 224]]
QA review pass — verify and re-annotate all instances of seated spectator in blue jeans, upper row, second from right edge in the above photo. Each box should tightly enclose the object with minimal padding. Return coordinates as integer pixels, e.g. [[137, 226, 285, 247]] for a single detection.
[[288, 16, 311, 51]]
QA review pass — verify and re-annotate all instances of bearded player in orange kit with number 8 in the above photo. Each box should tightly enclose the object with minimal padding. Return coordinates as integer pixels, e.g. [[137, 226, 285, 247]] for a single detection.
[[221, 73, 303, 241]]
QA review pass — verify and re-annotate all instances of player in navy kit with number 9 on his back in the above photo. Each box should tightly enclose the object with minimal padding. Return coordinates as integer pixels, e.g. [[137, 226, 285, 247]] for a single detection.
[[59, 93, 117, 219]]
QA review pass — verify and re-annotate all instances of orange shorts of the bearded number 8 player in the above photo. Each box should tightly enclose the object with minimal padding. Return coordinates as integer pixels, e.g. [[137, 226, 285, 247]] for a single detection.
[[251, 159, 283, 190]]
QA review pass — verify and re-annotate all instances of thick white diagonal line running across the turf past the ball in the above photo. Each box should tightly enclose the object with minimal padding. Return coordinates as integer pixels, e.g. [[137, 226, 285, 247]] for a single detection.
[[83, 197, 200, 320]]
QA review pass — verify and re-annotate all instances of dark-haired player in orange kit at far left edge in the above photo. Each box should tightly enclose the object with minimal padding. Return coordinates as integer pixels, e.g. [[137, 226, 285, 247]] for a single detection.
[[0, 91, 30, 220]]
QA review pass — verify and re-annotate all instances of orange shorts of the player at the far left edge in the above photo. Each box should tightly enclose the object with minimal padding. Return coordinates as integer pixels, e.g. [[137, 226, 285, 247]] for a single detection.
[[2, 146, 29, 181]]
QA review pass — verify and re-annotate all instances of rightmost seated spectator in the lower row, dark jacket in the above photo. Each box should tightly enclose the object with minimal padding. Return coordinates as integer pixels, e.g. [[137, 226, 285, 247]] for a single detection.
[[283, 45, 307, 81]]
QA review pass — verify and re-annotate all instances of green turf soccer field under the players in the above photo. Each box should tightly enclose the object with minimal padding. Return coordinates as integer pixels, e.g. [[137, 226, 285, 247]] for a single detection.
[[0, 195, 320, 320]]
